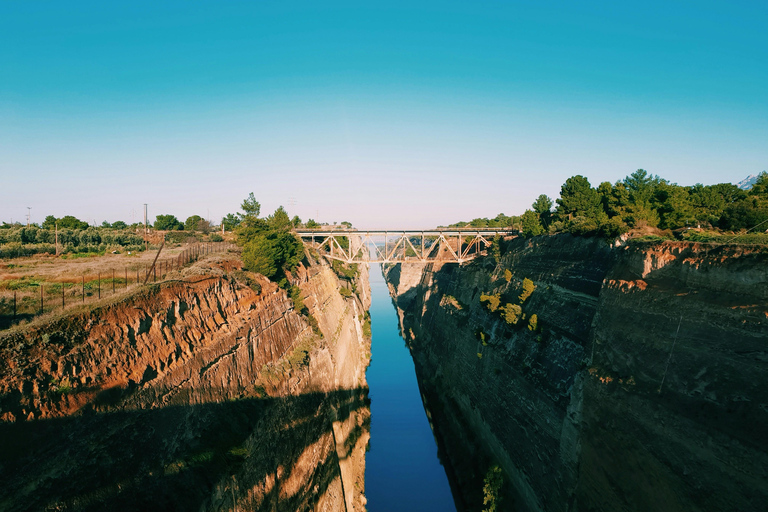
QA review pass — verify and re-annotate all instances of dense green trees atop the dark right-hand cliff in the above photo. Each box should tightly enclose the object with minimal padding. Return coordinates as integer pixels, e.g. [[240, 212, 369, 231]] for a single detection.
[[520, 169, 768, 237]]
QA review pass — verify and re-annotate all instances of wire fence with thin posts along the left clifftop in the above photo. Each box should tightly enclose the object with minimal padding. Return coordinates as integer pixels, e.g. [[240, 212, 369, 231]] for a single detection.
[[0, 242, 235, 329]]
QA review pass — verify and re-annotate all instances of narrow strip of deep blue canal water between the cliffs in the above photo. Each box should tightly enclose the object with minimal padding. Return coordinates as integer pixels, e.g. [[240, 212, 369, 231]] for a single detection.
[[365, 265, 456, 512]]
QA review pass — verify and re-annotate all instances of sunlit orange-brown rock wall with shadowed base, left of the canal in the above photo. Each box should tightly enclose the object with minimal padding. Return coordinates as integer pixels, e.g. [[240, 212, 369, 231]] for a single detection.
[[0, 254, 370, 511]]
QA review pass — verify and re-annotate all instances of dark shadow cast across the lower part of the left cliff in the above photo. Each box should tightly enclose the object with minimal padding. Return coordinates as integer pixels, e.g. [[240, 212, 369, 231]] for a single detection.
[[0, 388, 370, 511]]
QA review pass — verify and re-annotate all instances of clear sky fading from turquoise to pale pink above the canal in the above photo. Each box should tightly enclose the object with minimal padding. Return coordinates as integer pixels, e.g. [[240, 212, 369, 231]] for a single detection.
[[0, 0, 768, 229]]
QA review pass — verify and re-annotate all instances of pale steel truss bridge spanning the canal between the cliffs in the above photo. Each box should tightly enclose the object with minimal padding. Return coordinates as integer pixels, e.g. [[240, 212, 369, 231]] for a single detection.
[[296, 229, 517, 263]]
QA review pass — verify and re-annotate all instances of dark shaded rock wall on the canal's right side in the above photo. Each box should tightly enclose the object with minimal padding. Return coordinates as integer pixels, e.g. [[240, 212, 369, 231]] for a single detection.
[[386, 235, 768, 511]]
